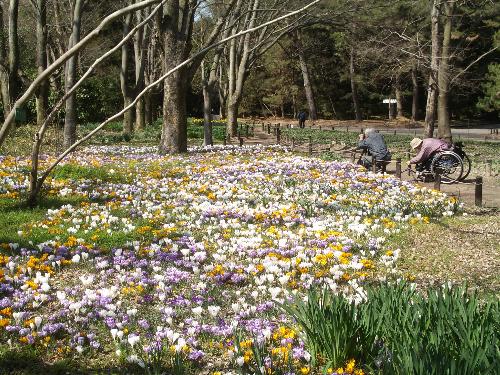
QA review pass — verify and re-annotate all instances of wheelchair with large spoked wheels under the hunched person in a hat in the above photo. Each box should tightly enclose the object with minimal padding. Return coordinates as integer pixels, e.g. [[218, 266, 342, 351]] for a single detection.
[[416, 142, 471, 184]]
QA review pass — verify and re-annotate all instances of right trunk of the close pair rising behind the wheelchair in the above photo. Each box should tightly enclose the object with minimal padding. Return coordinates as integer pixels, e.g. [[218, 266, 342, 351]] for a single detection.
[[438, 1, 455, 142]]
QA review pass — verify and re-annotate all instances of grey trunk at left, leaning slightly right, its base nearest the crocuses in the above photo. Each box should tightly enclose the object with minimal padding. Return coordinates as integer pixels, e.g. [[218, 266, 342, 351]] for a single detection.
[[64, 0, 84, 148]]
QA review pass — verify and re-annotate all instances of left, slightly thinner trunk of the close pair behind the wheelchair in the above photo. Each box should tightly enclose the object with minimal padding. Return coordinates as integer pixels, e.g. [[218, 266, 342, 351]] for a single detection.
[[424, 0, 441, 138]]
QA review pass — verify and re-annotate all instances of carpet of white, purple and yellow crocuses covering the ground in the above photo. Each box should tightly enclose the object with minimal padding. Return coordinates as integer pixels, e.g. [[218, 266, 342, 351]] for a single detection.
[[0, 146, 458, 374]]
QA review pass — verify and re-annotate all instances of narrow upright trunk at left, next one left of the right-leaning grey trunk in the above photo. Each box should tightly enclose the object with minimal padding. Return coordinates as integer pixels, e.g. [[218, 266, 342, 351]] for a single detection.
[[36, 0, 49, 126]]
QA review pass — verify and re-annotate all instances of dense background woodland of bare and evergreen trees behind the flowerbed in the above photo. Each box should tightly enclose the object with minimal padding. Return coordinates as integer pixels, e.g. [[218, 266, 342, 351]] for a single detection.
[[0, 0, 500, 154]]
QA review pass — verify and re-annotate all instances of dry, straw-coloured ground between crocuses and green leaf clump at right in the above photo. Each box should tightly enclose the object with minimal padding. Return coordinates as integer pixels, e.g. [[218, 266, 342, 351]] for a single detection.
[[391, 211, 500, 294]]
